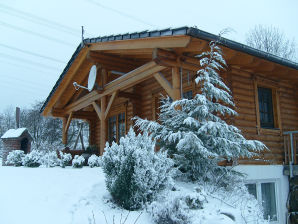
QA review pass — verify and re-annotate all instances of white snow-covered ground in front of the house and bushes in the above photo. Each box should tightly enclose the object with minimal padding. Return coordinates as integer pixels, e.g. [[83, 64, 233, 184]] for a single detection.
[[0, 163, 266, 224]]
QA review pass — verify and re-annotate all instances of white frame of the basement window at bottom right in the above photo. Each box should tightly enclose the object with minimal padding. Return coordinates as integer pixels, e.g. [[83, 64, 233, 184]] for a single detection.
[[245, 179, 280, 224]]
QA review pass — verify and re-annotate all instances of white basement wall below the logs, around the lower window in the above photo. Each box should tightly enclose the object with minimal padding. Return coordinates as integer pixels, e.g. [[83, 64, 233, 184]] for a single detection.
[[235, 165, 289, 224]]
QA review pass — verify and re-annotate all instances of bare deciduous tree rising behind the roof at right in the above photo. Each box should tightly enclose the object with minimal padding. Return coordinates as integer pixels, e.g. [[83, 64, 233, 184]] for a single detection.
[[246, 25, 297, 60]]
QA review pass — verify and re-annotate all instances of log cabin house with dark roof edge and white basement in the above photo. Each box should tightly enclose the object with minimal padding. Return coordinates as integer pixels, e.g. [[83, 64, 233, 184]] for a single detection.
[[41, 27, 298, 223]]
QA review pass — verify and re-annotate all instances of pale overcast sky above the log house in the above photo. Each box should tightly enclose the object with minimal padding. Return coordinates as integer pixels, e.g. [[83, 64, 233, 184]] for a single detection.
[[0, 0, 298, 112]]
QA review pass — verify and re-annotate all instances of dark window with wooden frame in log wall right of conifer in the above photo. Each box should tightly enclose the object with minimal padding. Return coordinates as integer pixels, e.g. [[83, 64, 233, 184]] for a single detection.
[[254, 77, 281, 134]]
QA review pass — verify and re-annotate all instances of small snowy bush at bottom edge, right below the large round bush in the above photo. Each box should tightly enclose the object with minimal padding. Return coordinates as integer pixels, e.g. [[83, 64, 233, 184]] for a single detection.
[[150, 197, 191, 224]]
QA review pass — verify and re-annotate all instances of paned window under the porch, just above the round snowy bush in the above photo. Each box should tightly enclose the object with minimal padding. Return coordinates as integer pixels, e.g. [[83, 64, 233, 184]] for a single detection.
[[108, 112, 126, 144]]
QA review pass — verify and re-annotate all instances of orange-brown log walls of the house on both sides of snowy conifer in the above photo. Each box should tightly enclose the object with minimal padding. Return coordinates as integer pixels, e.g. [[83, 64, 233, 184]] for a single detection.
[[91, 65, 298, 164]]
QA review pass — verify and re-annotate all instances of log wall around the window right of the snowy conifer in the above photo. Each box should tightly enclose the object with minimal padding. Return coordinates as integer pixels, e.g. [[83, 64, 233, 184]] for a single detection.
[[228, 68, 298, 164]]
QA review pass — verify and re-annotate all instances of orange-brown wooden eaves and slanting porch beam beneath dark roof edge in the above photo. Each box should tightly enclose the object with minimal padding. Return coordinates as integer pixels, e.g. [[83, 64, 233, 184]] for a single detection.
[[42, 32, 298, 118]]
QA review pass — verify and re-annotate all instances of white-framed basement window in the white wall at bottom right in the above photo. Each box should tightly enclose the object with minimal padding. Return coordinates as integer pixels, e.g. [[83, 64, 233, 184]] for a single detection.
[[246, 182, 277, 221]]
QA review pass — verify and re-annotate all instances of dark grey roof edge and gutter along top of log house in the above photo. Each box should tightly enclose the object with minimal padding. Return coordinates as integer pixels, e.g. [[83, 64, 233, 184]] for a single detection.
[[40, 26, 298, 113]]
